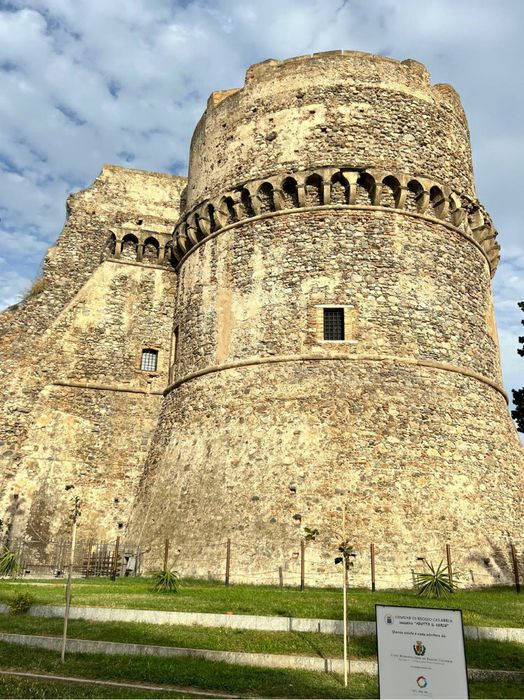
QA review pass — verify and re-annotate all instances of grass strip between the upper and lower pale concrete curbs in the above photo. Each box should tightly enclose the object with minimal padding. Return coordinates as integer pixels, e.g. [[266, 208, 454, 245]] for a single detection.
[[0, 615, 524, 671]]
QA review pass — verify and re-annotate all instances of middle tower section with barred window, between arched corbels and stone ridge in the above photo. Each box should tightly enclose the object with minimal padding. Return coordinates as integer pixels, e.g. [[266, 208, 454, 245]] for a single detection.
[[175, 207, 501, 392]]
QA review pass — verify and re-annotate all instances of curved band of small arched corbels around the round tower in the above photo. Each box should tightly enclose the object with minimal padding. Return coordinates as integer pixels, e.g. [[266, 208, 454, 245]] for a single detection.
[[173, 166, 500, 276]]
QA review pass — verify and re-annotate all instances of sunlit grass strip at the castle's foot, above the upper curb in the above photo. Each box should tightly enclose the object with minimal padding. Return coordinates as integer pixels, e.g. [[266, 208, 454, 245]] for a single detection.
[[0, 578, 524, 627]]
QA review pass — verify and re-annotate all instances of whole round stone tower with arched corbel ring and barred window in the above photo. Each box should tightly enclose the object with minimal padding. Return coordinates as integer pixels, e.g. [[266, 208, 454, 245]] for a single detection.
[[131, 51, 524, 586]]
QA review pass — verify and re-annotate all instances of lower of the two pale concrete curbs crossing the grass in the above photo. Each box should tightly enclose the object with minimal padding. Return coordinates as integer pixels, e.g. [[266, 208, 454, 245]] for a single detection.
[[0, 632, 524, 682]]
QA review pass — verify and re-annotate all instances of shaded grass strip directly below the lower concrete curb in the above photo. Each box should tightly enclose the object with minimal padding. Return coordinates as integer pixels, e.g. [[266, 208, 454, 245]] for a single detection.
[[0, 643, 522, 698]]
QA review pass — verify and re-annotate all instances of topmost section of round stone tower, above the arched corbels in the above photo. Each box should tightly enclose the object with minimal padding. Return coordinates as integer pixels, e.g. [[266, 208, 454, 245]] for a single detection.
[[188, 52, 475, 207]]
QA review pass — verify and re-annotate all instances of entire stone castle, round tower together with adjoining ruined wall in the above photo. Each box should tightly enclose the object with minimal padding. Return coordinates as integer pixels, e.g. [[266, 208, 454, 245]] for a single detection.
[[0, 51, 524, 583]]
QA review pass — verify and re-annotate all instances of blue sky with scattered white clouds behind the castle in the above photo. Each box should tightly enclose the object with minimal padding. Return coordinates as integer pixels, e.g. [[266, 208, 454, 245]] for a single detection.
[[0, 0, 524, 412]]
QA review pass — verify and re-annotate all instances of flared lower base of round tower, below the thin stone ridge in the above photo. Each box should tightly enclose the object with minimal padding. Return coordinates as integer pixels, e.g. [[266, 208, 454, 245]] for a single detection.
[[131, 360, 524, 587]]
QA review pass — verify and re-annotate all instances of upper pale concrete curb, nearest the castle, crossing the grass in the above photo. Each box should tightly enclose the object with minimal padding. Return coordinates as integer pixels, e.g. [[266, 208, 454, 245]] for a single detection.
[[0, 604, 524, 644]]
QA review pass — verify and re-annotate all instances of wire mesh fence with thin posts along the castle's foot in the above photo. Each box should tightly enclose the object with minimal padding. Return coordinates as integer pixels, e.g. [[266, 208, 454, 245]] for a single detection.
[[3, 538, 524, 590]]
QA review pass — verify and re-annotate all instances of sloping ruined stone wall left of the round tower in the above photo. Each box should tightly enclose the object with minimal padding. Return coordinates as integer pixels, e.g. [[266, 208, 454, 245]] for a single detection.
[[0, 167, 185, 540]]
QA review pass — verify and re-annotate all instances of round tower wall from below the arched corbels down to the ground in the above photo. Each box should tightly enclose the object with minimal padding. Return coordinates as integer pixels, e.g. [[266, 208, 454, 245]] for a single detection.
[[131, 207, 524, 584]]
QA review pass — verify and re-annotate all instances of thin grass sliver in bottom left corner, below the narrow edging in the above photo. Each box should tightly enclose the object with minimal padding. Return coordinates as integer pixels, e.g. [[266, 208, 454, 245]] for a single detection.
[[0, 675, 189, 700]]
